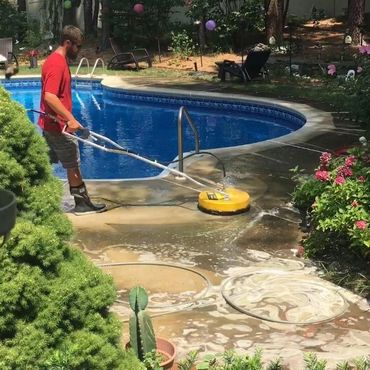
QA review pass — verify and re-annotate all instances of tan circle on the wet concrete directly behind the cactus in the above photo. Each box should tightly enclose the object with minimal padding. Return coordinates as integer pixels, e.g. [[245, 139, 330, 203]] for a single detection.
[[100, 262, 210, 309]]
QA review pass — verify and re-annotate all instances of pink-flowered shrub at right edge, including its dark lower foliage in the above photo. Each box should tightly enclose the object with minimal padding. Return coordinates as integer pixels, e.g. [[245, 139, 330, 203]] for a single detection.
[[292, 139, 370, 282]]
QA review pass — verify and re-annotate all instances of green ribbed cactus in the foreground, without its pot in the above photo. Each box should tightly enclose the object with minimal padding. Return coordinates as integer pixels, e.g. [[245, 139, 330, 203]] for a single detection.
[[129, 286, 156, 361]]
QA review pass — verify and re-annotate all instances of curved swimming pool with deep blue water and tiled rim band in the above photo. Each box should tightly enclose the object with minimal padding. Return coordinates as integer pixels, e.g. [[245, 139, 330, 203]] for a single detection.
[[3, 80, 306, 179]]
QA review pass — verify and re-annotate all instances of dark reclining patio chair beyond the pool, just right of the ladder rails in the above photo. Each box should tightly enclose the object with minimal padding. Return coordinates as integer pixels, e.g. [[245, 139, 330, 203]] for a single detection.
[[108, 38, 152, 70]]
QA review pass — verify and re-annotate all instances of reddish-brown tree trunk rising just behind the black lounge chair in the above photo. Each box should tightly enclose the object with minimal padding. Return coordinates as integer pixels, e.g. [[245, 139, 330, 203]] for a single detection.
[[265, 0, 284, 45]]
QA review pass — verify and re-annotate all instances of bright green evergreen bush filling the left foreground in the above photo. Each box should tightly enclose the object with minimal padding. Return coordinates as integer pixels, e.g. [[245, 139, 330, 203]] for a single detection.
[[0, 87, 142, 370]]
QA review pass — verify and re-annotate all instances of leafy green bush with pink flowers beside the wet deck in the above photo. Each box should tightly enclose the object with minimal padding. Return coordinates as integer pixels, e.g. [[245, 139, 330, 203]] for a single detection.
[[293, 142, 370, 258]]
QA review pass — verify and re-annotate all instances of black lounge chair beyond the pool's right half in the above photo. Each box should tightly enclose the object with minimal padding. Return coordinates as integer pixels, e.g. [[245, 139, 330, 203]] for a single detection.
[[216, 44, 271, 82]]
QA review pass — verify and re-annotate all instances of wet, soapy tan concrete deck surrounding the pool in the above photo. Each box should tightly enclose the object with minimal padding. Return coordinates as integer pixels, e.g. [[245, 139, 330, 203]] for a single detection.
[[66, 77, 370, 370]]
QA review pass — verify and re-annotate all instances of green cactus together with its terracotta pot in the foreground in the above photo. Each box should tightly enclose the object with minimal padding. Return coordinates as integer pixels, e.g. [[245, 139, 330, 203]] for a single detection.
[[126, 286, 176, 370]]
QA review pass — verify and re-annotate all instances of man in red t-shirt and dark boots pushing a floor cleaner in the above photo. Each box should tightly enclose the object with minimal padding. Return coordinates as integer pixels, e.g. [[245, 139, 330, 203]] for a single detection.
[[38, 26, 106, 214]]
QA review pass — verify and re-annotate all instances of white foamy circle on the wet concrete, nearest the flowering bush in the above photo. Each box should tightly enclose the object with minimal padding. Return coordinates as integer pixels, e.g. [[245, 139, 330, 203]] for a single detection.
[[222, 270, 348, 324]]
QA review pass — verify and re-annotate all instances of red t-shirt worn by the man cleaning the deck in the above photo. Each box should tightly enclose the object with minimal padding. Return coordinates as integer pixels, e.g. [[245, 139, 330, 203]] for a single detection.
[[38, 52, 72, 132]]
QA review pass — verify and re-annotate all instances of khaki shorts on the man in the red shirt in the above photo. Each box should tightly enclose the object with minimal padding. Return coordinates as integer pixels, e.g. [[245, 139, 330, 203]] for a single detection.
[[43, 131, 80, 169]]
